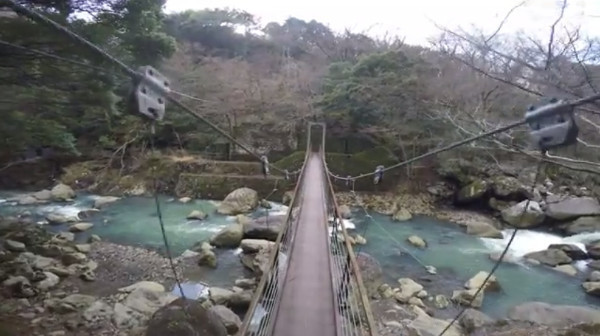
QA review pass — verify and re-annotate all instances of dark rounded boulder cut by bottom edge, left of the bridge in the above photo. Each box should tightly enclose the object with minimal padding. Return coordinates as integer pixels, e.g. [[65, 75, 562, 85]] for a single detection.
[[146, 299, 227, 336]]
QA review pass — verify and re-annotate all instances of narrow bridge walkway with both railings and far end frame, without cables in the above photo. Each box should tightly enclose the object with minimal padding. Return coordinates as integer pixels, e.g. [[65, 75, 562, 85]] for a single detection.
[[239, 123, 376, 336]]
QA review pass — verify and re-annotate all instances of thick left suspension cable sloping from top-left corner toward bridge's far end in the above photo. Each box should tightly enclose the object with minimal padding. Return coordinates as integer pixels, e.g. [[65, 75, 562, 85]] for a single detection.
[[0, 0, 285, 174]]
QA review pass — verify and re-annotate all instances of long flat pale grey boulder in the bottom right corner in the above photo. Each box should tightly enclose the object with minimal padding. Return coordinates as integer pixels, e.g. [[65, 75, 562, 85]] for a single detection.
[[508, 302, 600, 327]]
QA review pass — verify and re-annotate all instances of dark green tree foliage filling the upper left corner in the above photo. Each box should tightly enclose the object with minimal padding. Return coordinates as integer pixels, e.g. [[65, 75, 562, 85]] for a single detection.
[[0, 0, 175, 158]]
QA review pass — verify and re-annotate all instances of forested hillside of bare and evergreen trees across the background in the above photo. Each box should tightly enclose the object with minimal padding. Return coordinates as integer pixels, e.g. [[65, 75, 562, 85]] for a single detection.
[[0, 0, 600, 184]]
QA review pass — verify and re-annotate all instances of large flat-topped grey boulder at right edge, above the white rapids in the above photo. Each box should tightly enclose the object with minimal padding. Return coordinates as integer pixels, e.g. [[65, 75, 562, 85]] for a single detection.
[[546, 197, 600, 220]]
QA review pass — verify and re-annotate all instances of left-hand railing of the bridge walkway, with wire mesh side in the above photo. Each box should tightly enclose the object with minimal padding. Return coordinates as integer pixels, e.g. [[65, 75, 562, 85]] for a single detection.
[[238, 124, 311, 336]]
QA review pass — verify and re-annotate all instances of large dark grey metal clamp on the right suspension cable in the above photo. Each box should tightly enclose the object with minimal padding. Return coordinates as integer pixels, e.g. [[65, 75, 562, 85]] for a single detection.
[[525, 98, 579, 151]]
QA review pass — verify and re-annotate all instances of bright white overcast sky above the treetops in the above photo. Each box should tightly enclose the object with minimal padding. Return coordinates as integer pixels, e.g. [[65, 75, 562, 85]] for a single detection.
[[166, 0, 600, 45]]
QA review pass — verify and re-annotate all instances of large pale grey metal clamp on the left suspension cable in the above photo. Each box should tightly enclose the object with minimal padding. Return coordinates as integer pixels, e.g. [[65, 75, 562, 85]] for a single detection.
[[132, 66, 171, 121]]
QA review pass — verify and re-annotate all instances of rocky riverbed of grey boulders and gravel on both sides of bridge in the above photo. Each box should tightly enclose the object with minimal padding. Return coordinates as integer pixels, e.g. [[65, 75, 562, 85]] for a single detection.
[[0, 176, 600, 336]]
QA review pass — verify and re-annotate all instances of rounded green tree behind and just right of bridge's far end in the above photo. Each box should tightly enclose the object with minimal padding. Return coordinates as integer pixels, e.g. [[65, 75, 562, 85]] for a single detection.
[[318, 51, 422, 130]]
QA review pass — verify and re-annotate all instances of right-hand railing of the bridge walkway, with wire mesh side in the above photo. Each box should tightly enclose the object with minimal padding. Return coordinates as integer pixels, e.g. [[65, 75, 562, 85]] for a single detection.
[[321, 125, 377, 336]]
